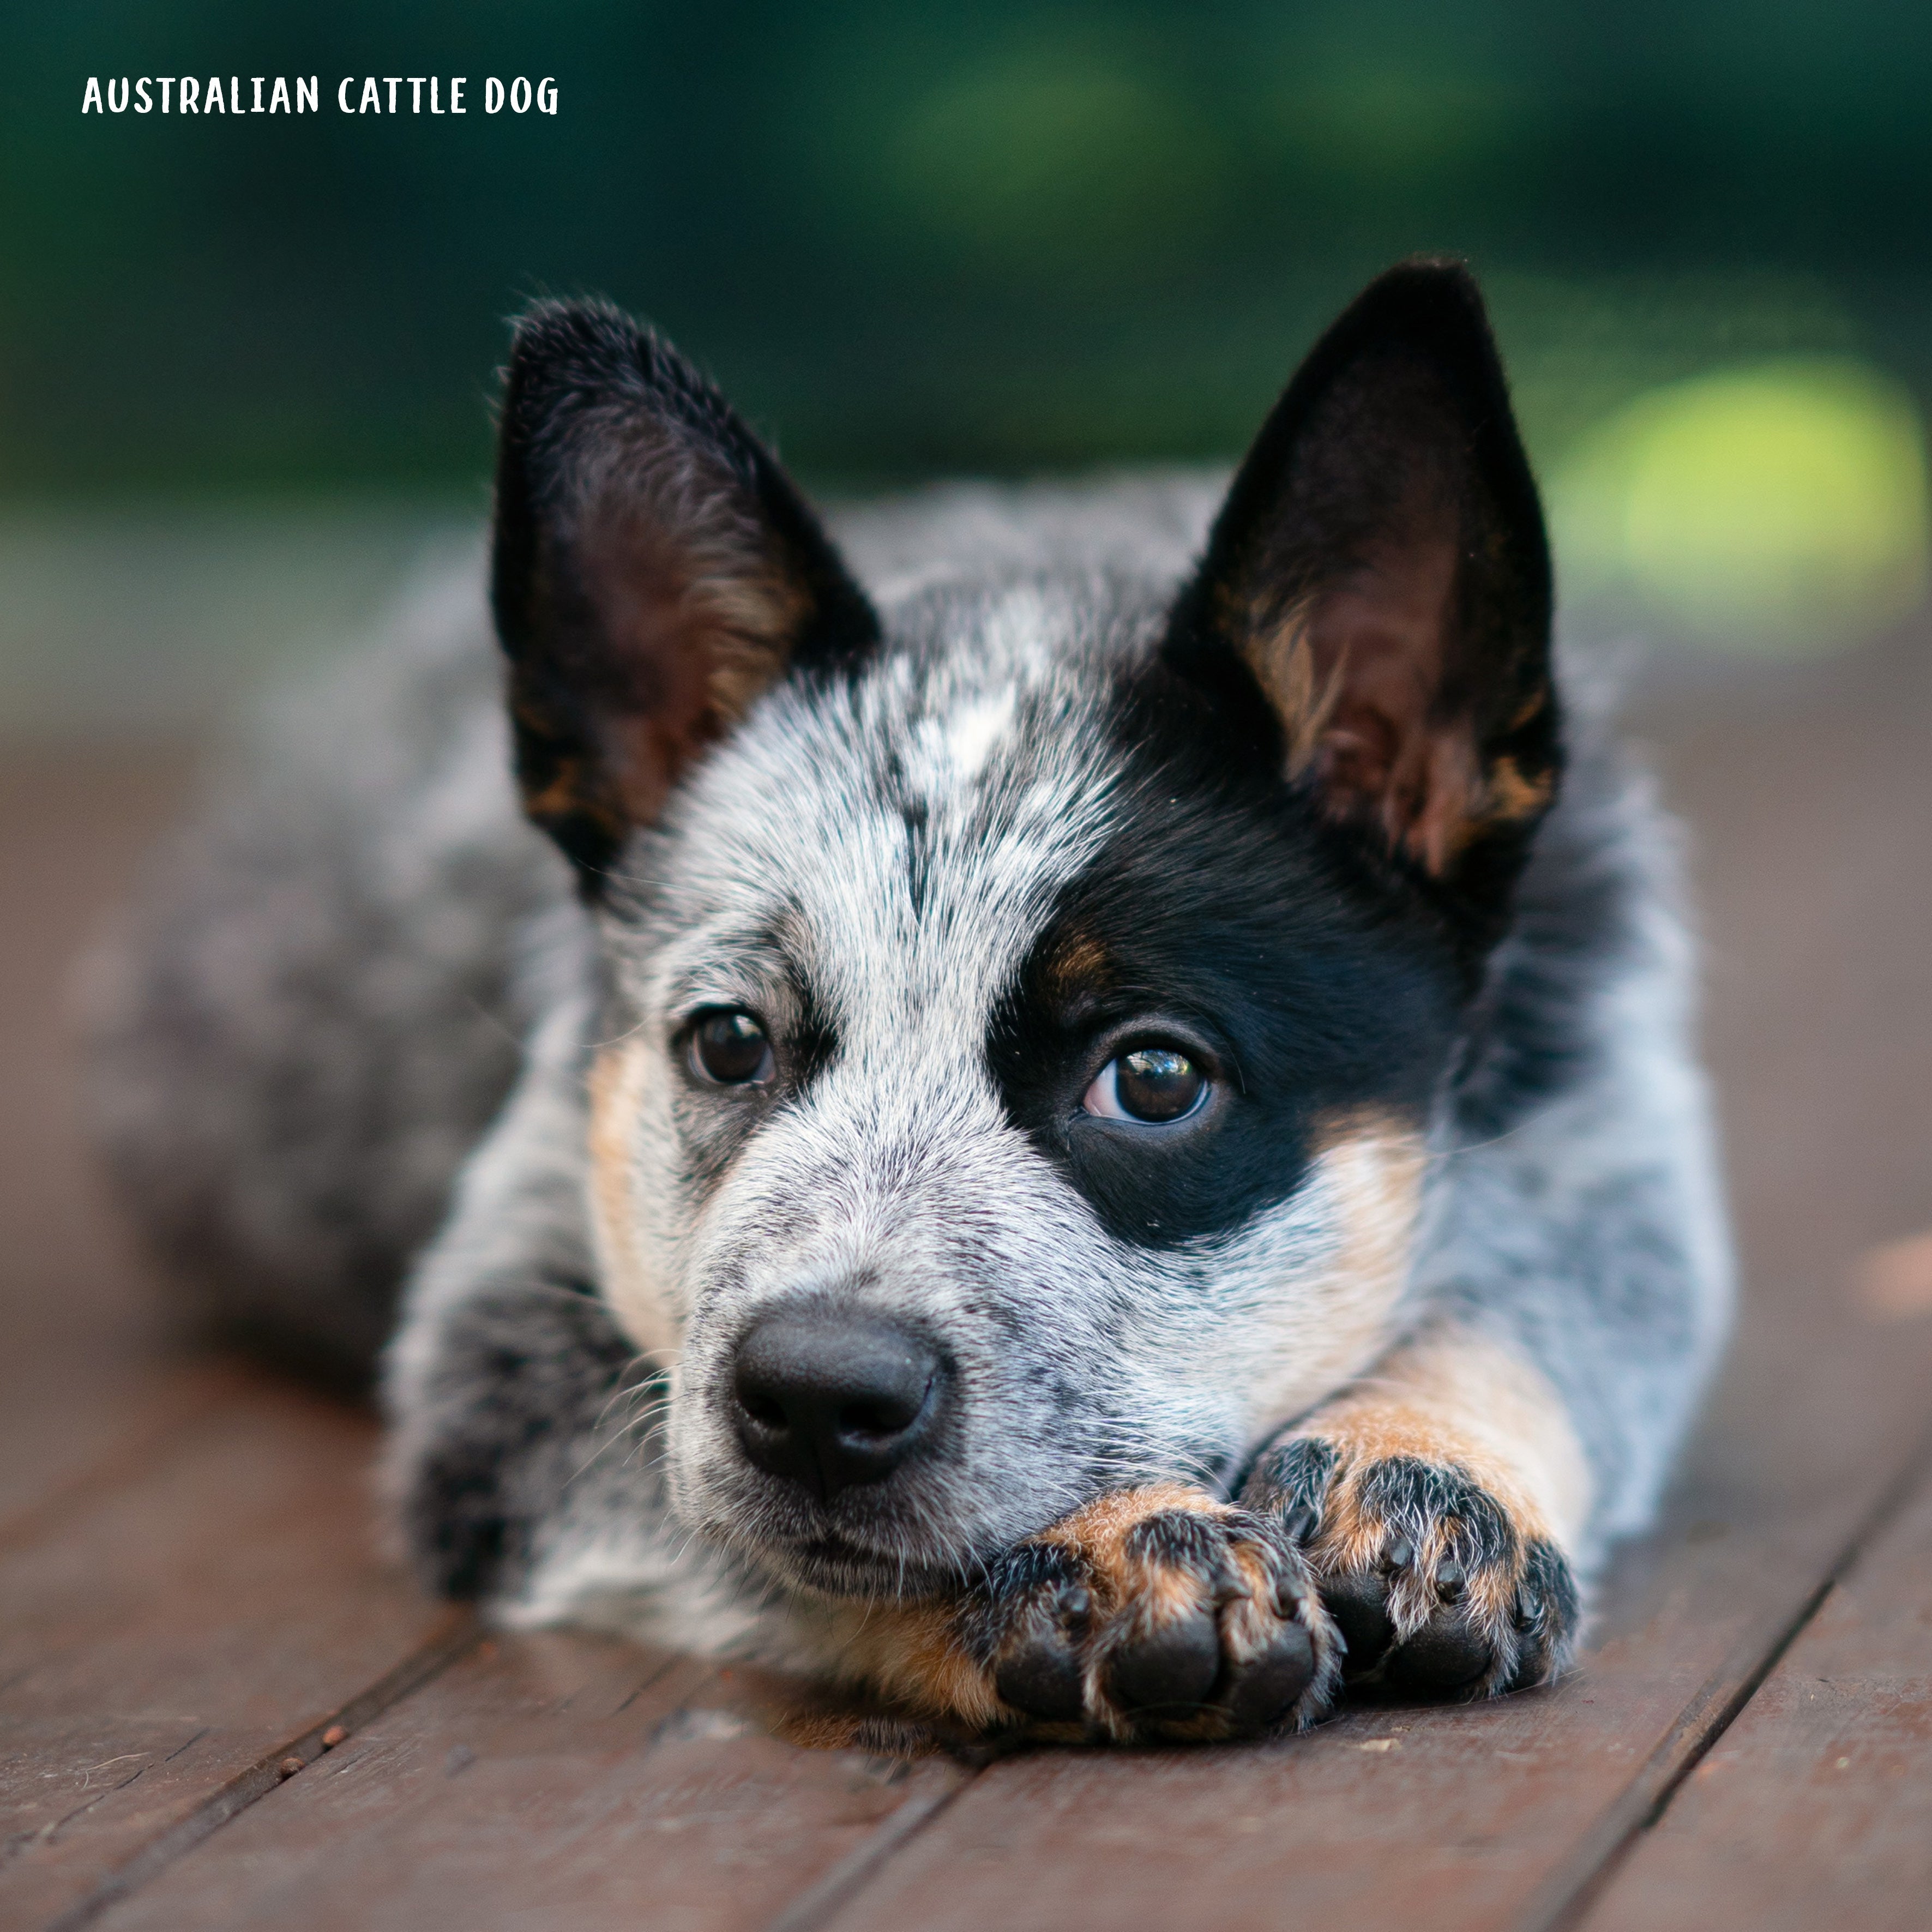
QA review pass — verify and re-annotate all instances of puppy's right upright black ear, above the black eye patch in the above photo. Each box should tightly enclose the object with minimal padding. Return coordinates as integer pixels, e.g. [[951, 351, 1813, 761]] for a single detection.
[[1167, 261, 1561, 950]]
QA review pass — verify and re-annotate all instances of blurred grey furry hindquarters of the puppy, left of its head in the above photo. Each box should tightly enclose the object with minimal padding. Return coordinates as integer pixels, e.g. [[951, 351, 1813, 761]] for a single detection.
[[81, 558, 576, 1385]]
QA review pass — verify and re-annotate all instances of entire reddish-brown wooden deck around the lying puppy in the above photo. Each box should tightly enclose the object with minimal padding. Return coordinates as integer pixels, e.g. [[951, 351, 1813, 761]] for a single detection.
[[0, 637, 1932, 1932]]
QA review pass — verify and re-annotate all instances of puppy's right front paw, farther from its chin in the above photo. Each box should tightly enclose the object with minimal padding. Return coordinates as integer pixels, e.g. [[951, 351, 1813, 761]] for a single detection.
[[1242, 1422, 1576, 1698]]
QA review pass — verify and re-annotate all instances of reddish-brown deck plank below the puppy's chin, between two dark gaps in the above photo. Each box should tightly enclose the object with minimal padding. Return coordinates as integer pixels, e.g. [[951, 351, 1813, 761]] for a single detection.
[[100, 1634, 964, 1932]]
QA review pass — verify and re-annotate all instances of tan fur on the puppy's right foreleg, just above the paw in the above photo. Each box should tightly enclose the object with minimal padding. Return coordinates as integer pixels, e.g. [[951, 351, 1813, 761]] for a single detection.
[[1296, 1327, 1594, 1567]]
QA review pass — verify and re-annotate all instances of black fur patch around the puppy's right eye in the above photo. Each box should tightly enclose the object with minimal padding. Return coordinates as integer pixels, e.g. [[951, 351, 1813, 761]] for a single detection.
[[987, 688, 1459, 1246]]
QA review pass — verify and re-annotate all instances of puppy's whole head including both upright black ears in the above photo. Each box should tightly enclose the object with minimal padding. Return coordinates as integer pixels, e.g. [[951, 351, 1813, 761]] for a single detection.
[[495, 263, 1559, 1594]]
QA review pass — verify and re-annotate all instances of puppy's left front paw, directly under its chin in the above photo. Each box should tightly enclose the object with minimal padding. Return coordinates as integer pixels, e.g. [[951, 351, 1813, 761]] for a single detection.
[[960, 1484, 1341, 1741]]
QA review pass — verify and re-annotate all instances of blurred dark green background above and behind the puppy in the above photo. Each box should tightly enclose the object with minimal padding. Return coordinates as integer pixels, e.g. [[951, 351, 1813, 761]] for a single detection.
[[0, 0, 1932, 729]]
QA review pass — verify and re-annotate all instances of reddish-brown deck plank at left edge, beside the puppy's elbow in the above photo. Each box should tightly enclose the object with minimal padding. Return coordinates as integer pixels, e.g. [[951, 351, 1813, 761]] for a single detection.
[[0, 1383, 446, 1924]]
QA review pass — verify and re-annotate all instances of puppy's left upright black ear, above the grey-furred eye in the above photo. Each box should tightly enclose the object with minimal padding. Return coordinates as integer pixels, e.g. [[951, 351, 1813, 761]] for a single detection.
[[492, 303, 877, 894]]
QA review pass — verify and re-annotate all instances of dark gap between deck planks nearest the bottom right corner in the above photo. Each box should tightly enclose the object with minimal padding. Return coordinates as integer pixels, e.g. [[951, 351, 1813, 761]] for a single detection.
[[1515, 1426, 1932, 1932]]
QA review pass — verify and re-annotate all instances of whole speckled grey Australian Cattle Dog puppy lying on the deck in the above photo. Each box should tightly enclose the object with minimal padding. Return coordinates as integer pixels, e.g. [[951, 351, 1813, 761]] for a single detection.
[[91, 249, 1727, 1741]]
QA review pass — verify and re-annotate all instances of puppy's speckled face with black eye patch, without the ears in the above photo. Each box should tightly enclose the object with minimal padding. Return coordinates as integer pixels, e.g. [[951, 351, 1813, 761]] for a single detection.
[[593, 587, 1455, 1590]]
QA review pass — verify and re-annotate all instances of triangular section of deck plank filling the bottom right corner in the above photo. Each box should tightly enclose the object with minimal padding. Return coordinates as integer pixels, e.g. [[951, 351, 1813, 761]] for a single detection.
[[1584, 1453, 1932, 1932]]
